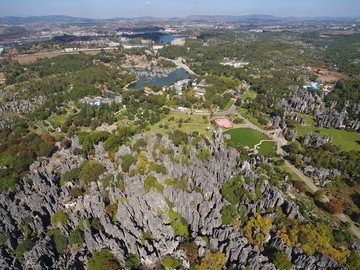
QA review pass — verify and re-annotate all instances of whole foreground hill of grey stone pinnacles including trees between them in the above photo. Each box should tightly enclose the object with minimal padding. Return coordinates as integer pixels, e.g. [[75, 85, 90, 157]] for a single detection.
[[0, 130, 346, 270]]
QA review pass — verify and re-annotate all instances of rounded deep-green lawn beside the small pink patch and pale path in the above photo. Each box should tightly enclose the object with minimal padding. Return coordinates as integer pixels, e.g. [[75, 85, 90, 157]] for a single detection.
[[224, 128, 270, 148]]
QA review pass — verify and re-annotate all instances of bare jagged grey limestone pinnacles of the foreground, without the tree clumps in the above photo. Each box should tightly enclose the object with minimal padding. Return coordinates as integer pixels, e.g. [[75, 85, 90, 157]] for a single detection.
[[0, 131, 344, 270]]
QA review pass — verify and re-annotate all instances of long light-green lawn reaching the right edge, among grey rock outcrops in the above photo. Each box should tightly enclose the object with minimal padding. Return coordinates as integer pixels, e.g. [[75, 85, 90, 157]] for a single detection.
[[297, 126, 360, 151]]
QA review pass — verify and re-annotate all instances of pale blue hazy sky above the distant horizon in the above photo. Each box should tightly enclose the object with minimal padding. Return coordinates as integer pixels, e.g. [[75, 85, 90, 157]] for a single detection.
[[0, 0, 360, 19]]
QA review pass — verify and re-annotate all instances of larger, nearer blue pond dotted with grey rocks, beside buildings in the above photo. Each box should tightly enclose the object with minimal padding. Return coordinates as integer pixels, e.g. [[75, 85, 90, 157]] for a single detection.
[[130, 69, 189, 89]]
